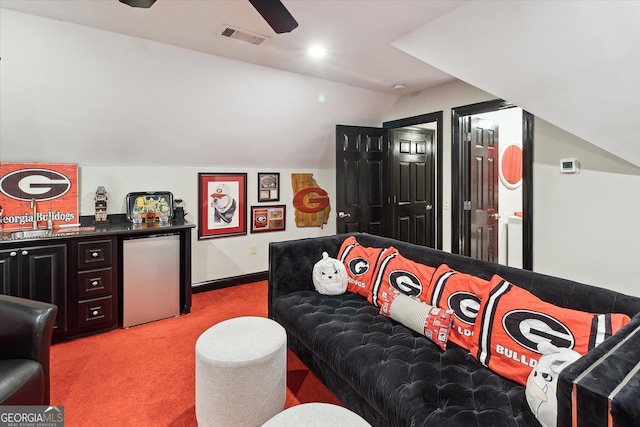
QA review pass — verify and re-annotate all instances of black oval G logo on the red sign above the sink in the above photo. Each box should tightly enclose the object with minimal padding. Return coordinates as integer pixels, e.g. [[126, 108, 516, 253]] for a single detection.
[[0, 169, 71, 202]]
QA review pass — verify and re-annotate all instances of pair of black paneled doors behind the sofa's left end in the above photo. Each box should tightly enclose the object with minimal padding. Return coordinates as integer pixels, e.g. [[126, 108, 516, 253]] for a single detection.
[[336, 125, 436, 247]]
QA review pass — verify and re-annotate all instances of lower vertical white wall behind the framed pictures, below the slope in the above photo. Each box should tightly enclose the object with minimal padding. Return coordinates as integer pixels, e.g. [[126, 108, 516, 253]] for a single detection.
[[80, 166, 336, 284]]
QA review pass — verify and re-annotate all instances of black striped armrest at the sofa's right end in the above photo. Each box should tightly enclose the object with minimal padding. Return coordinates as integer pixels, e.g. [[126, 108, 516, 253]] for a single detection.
[[556, 313, 640, 426]]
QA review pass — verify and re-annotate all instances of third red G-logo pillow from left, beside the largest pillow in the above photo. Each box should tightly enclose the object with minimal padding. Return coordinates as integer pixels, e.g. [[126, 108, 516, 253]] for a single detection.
[[425, 264, 489, 350]]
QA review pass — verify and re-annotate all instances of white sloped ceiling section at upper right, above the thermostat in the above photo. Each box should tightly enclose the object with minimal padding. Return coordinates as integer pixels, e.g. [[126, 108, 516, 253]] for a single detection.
[[393, 1, 640, 166]]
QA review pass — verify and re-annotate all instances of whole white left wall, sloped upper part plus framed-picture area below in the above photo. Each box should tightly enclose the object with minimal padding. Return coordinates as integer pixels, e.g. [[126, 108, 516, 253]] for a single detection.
[[0, 9, 397, 283]]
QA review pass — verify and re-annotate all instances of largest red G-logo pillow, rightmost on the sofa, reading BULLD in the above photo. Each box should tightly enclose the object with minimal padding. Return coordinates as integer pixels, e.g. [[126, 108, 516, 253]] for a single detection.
[[471, 275, 630, 385]]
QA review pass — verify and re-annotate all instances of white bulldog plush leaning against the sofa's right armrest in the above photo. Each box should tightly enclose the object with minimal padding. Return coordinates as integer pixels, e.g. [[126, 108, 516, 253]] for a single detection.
[[525, 342, 580, 427]]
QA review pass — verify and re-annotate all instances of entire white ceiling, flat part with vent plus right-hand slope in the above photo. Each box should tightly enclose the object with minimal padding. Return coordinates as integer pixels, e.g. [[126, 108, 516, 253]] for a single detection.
[[0, 0, 640, 166]]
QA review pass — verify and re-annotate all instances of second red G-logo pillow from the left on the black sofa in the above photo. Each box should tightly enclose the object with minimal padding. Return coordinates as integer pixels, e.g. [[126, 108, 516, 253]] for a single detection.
[[369, 250, 436, 307]]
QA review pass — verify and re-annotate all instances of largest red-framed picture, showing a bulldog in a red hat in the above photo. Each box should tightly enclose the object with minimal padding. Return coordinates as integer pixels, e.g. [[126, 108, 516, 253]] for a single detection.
[[198, 173, 247, 240]]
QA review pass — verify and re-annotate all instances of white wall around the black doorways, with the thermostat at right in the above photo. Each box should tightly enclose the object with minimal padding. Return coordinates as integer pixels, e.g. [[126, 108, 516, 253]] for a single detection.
[[385, 81, 640, 296]]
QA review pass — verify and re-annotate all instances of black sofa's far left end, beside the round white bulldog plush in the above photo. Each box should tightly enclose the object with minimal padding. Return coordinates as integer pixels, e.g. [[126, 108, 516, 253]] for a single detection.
[[268, 234, 349, 317]]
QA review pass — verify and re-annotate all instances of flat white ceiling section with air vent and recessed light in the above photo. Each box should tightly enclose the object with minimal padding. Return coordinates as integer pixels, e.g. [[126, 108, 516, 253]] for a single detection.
[[0, 0, 466, 95]]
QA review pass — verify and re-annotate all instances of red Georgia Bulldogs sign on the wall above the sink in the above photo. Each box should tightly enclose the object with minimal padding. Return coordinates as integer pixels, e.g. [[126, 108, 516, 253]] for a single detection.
[[0, 163, 79, 228]]
